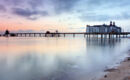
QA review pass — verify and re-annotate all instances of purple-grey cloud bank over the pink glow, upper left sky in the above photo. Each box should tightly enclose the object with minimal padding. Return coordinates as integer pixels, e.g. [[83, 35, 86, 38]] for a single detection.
[[0, 0, 78, 20]]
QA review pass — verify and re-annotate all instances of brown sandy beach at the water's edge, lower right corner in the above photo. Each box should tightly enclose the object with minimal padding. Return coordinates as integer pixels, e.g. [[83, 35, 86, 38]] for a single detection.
[[99, 50, 130, 80]]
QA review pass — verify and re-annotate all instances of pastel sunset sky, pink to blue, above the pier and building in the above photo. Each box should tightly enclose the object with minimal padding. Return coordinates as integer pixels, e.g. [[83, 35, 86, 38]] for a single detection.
[[0, 0, 130, 32]]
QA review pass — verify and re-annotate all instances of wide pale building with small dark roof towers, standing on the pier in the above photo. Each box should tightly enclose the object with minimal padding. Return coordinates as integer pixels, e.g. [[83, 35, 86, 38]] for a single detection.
[[86, 21, 121, 33]]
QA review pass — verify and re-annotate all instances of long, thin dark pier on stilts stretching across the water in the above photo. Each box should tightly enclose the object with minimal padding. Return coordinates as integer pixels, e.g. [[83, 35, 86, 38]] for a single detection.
[[9, 32, 130, 38]]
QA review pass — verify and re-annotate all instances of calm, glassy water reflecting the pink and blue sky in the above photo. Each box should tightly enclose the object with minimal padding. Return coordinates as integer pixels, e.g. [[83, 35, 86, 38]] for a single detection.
[[0, 37, 130, 80]]
